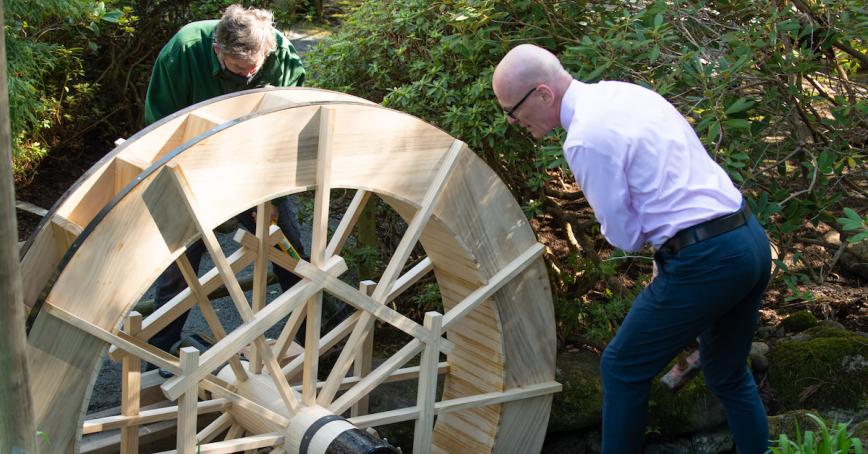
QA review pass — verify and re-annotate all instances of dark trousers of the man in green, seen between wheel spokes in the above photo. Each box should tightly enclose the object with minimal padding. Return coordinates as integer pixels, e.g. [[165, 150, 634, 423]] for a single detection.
[[148, 197, 305, 351]]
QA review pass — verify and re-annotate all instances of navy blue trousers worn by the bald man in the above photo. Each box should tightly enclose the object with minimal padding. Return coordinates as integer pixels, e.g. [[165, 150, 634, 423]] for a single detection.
[[600, 216, 771, 454]]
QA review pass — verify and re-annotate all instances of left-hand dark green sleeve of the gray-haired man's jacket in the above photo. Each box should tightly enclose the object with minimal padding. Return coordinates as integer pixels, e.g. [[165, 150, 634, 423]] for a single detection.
[[145, 48, 192, 125]]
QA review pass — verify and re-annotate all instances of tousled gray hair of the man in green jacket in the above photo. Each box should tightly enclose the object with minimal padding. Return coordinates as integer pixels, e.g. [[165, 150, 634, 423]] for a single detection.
[[214, 4, 277, 61]]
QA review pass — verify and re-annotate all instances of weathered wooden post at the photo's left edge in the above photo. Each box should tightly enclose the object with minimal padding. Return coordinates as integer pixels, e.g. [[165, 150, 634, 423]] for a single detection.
[[0, 0, 37, 453]]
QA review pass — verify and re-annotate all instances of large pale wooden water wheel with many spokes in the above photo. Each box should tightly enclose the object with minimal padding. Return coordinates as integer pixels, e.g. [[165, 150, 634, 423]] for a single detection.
[[22, 89, 560, 453]]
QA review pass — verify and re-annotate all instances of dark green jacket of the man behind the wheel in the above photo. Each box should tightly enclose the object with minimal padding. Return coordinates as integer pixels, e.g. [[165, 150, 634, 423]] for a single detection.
[[145, 20, 304, 124]]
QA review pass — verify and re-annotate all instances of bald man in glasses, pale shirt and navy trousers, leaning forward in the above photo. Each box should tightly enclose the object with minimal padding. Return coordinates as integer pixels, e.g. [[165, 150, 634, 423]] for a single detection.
[[492, 44, 771, 454]]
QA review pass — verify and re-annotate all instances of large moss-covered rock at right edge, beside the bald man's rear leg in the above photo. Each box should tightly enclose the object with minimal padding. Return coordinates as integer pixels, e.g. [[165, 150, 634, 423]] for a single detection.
[[768, 325, 868, 409]]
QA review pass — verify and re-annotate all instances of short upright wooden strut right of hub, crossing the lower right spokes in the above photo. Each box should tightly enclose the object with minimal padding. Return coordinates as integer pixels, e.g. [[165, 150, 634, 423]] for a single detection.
[[413, 312, 443, 454]]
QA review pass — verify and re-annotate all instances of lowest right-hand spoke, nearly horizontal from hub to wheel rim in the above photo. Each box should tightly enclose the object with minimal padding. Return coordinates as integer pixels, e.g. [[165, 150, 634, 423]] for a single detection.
[[348, 382, 561, 428]]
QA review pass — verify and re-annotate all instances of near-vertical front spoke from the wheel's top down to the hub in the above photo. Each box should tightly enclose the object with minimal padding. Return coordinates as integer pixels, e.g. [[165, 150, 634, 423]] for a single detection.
[[301, 107, 335, 405]]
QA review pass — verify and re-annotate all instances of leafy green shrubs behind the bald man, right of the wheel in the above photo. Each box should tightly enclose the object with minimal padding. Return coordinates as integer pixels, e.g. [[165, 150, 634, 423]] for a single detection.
[[306, 0, 868, 343]]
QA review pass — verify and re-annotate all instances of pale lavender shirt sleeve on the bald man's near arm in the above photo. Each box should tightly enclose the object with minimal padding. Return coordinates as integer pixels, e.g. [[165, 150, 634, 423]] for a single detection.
[[565, 135, 645, 251]]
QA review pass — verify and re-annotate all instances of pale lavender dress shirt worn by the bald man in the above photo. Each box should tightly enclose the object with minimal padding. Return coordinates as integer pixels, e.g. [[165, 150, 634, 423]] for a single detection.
[[561, 80, 742, 251]]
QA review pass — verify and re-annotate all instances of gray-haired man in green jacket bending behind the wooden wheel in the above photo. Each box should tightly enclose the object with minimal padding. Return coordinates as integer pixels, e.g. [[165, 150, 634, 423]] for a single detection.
[[145, 5, 305, 358]]
